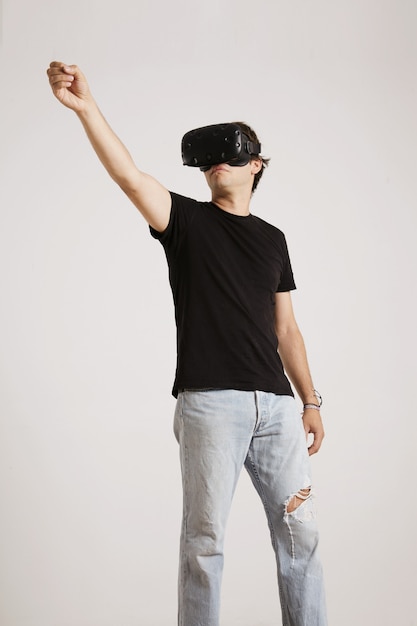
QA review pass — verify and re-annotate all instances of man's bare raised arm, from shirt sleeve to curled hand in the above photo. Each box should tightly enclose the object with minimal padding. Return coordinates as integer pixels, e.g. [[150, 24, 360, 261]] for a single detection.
[[47, 61, 171, 232]]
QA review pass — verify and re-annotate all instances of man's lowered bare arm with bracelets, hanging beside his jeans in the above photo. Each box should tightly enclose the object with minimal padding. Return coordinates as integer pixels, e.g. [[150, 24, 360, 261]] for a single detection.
[[275, 291, 324, 455]]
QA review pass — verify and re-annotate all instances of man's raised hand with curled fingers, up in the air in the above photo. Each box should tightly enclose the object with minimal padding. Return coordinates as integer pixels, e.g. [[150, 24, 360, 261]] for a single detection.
[[47, 61, 92, 113]]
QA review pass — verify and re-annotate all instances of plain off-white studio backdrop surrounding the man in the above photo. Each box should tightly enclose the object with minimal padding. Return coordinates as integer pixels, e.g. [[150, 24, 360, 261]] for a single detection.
[[0, 0, 417, 626]]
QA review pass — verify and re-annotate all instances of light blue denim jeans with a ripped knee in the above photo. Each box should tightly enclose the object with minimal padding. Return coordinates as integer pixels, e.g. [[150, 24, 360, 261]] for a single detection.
[[174, 389, 327, 626]]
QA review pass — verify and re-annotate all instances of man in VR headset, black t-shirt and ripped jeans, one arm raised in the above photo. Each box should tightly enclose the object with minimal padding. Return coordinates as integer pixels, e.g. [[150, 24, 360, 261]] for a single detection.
[[48, 62, 327, 626]]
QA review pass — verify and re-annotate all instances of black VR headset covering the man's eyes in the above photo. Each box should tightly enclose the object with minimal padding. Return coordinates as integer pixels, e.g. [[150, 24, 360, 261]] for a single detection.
[[181, 124, 261, 172]]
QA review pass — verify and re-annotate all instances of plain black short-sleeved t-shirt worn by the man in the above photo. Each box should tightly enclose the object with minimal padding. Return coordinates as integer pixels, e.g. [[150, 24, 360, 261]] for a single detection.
[[151, 193, 295, 397]]
